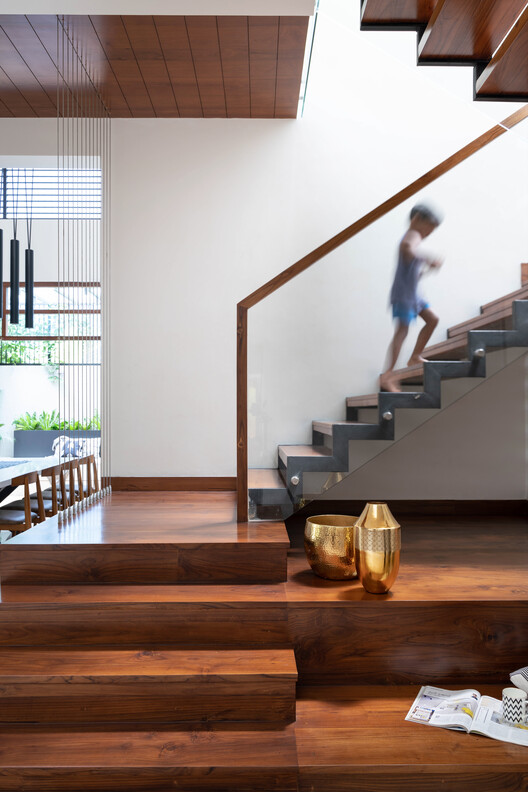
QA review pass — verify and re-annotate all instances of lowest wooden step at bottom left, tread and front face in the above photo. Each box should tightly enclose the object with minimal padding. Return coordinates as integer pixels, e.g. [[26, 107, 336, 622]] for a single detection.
[[0, 725, 297, 792]]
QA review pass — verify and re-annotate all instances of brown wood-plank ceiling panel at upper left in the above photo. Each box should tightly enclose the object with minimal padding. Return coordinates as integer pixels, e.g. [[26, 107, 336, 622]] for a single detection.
[[0, 14, 309, 118]]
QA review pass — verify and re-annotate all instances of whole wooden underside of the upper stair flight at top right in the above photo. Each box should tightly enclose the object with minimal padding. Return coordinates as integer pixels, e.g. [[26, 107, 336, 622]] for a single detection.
[[361, 0, 528, 101]]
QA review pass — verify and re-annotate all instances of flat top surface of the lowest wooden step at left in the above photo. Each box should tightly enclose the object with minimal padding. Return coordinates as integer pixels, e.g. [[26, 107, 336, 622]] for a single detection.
[[0, 726, 297, 768]]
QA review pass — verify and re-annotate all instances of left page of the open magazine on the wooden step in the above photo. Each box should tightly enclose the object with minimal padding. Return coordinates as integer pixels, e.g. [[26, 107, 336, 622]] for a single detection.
[[405, 685, 480, 732]]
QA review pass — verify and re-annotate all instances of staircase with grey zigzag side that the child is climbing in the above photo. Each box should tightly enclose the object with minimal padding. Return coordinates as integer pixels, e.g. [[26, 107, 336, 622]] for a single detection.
[[249, 286, 528, 518]]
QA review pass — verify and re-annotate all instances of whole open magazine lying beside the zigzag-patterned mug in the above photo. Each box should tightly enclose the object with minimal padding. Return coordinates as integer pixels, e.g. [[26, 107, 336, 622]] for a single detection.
[[405, 685, 528, 745]]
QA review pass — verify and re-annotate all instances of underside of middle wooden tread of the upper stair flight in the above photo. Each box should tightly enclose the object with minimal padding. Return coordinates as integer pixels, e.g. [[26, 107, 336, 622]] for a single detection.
[[418, 0, 525, 62]]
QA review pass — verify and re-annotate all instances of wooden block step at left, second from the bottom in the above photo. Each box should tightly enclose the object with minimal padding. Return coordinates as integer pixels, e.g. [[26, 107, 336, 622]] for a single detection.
[[0, 646, 297, 724]]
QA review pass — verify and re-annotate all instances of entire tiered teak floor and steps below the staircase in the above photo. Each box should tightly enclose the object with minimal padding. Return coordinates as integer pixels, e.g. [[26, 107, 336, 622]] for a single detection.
[[0, 493, 528, 792]]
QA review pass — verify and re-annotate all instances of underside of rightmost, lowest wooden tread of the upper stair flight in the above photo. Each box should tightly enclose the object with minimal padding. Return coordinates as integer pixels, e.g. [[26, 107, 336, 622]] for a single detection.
[[476, 6, 528, 101]]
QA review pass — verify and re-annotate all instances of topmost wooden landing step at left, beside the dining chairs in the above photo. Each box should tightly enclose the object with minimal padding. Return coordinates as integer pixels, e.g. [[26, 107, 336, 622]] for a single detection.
[[0, 492, 289, 583]]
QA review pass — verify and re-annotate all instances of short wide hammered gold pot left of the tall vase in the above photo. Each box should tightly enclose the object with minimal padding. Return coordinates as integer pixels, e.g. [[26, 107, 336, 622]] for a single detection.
[[304, 514, 357, 580]]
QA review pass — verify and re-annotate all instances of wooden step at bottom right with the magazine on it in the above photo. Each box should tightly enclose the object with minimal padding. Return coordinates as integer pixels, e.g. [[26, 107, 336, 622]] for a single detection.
[[296, 678, 528, 792]]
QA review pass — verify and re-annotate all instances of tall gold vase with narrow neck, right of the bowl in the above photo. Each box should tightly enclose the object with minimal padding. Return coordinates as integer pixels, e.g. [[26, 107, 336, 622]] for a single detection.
[[354, 503, 401, 594]]
